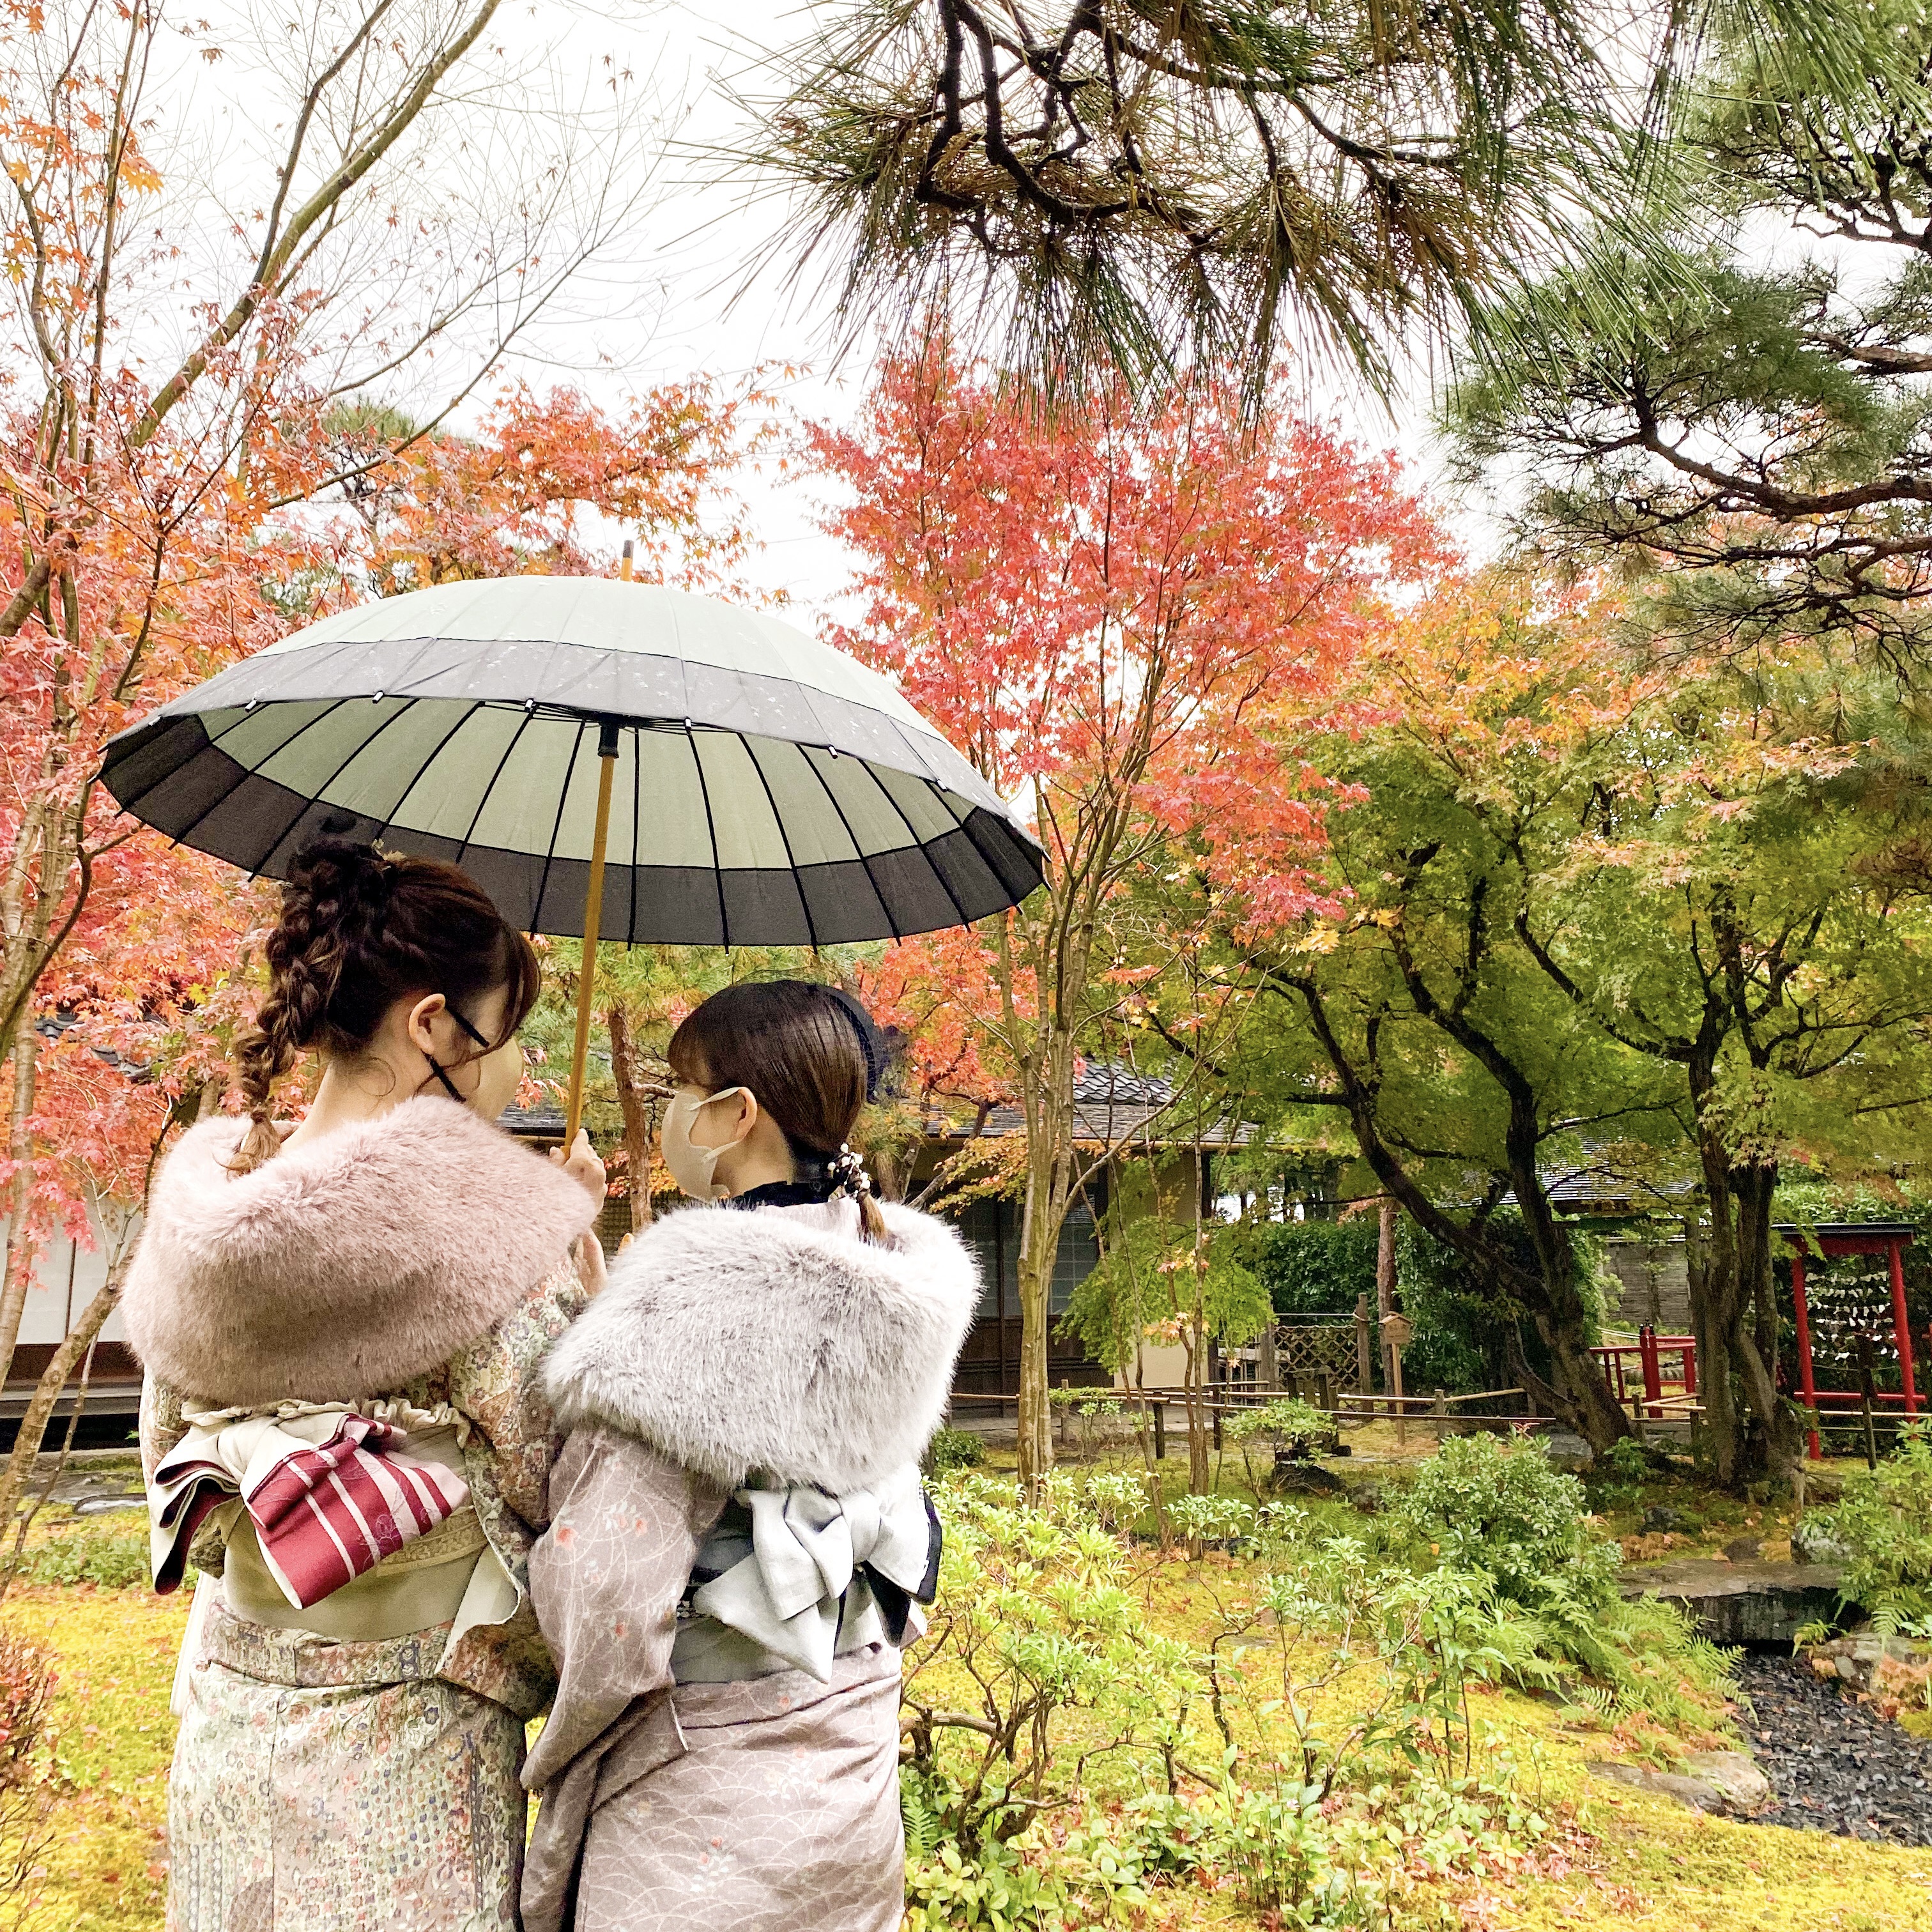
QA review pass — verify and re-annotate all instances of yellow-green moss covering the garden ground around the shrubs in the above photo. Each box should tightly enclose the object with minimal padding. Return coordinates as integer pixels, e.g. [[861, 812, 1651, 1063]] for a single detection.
[[0, 1432, 1932, 1932]]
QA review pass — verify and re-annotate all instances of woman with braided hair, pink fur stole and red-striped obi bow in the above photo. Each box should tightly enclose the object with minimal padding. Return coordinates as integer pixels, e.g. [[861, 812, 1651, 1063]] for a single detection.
[[124, 842, 605, 1932]]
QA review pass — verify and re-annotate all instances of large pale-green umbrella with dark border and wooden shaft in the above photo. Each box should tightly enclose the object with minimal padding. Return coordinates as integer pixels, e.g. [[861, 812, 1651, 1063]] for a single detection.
[[100, 578, 1041, 1134]]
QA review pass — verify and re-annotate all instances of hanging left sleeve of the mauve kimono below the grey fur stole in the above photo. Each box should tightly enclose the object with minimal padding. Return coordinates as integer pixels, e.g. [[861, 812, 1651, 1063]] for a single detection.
[[524, 1430, 726, 1791]]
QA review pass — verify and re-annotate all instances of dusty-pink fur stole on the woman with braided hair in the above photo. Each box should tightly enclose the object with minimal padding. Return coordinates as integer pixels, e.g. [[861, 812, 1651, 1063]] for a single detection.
[[122, 1098, 595, 1406]]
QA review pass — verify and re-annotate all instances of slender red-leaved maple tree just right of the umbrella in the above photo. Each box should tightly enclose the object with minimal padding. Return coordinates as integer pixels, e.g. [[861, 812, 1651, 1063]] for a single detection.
[[811, 351, 1447, 1480]]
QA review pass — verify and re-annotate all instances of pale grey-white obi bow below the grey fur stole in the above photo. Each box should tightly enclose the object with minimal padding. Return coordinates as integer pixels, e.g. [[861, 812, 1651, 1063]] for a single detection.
[[692, 1462, 930, 1683]]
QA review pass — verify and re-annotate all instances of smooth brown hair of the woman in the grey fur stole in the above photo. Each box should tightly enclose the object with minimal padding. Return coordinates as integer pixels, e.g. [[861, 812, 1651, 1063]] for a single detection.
[[664, 979, 885, 1240]]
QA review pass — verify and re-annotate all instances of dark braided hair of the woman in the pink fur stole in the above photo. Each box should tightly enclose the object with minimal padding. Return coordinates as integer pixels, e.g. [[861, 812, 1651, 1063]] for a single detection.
[[232, 838, 541, 1173]]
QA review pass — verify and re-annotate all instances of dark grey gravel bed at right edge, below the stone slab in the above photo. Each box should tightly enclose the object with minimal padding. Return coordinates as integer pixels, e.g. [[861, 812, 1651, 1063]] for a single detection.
[[1737, 1650, 1932, 1845]]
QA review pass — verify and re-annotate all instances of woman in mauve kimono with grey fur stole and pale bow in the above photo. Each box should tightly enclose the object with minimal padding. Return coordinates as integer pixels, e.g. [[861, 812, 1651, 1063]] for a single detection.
[[524, 979, 979, 1932]]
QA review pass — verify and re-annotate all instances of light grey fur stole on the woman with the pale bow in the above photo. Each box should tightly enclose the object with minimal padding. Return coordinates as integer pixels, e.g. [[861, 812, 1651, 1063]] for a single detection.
[[545, 1202, 979, 1494]]
